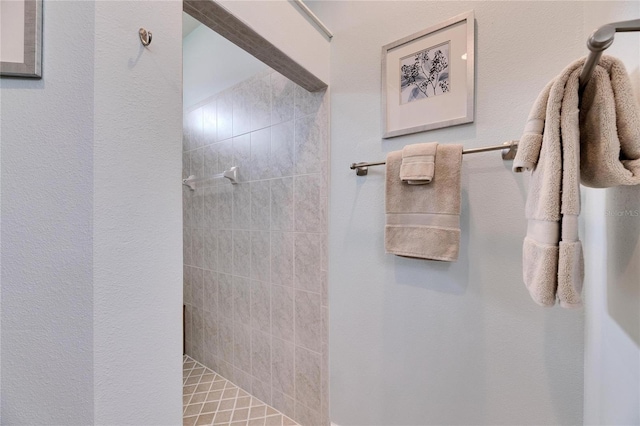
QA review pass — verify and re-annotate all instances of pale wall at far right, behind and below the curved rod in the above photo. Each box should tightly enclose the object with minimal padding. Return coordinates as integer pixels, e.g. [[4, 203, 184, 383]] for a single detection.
[[582, 2, 640, 425]]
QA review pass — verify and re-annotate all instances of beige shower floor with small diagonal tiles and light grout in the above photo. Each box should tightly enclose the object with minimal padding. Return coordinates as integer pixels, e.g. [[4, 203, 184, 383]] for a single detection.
[[182, 355, 298, 426]]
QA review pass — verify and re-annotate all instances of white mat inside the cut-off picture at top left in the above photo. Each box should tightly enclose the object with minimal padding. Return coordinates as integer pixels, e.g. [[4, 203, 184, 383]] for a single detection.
[[0, 0, 25, 64]]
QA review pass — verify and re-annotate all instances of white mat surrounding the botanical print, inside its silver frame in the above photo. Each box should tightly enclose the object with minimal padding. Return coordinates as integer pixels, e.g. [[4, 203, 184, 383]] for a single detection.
[[386, 21, 469, 132]]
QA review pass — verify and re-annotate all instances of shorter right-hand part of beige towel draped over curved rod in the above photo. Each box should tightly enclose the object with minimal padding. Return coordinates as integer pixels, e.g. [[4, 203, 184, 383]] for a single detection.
[[580, 56, 640, 188]]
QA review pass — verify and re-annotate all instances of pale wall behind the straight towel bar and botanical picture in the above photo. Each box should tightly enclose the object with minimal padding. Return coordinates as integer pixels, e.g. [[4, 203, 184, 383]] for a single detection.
[[311, 1, 589, 426]]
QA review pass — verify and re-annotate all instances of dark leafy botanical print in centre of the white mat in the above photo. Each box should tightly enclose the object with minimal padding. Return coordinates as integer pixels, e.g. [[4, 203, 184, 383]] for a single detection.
[[400, 41, 451, 105]]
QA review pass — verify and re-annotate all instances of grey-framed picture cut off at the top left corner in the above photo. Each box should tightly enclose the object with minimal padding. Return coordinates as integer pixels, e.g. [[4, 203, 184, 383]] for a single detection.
[[0, 0, 42, 78]]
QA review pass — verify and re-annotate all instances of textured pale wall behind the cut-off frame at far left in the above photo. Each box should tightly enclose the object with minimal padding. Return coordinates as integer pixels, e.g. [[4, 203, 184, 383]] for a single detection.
[[0, 2, 95, 424]]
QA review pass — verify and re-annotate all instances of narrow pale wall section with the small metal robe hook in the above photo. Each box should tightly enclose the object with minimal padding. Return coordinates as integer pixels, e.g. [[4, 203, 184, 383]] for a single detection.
[[93, 0, 182, 425]]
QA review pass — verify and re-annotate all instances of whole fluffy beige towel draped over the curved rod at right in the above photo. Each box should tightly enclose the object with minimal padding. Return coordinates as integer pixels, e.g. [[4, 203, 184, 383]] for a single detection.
[[513, 56, 640, 308]]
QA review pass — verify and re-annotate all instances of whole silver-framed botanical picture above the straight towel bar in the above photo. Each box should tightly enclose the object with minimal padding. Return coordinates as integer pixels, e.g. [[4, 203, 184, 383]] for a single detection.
[[382, 11, 475, 138]]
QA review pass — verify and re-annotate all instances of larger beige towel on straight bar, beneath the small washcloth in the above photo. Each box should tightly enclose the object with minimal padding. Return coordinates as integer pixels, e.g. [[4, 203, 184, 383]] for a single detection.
[[384, 145, 462, 262]]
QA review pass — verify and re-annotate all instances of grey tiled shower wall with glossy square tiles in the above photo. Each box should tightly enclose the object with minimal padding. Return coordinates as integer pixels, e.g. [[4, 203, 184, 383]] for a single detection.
[[183, 71, 329, 425]]
